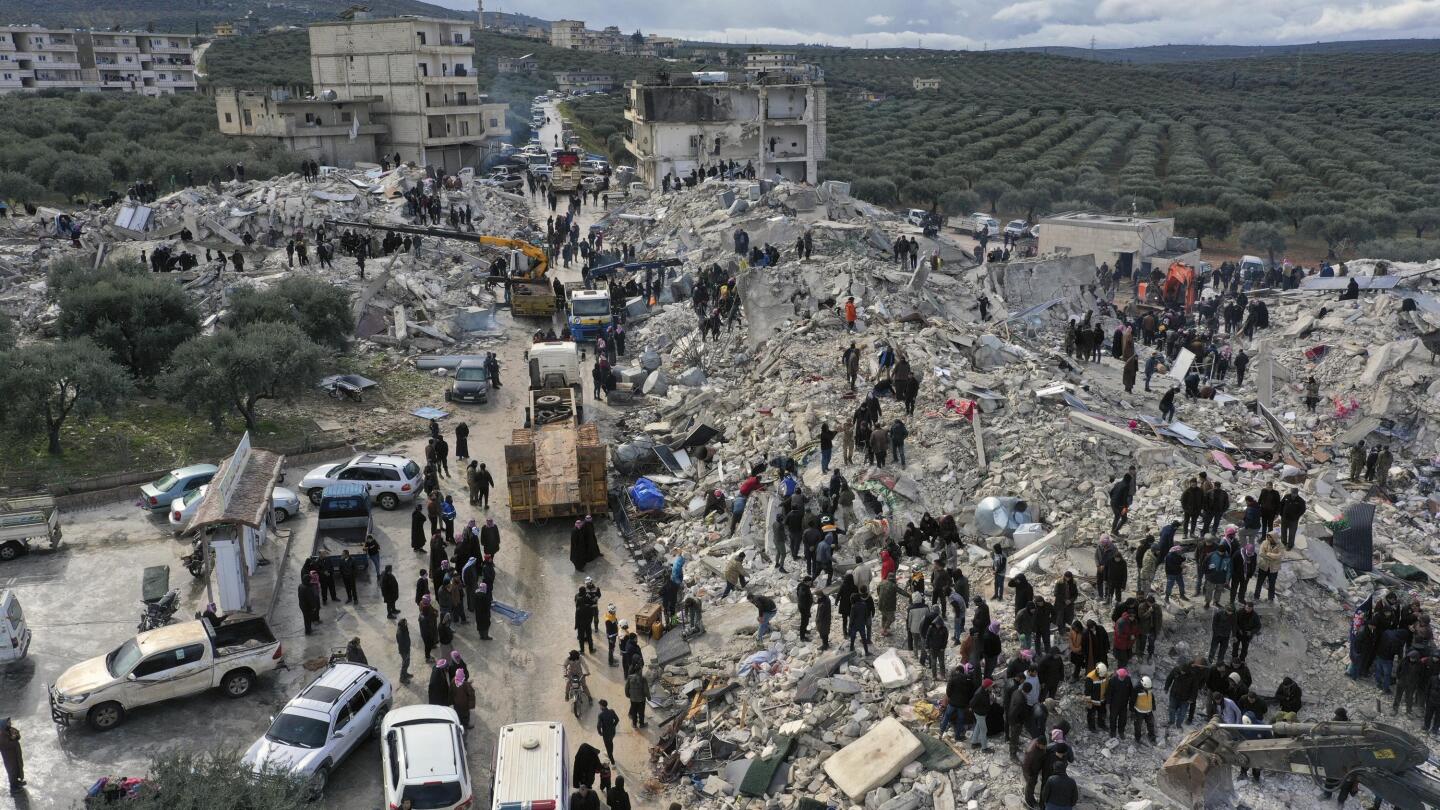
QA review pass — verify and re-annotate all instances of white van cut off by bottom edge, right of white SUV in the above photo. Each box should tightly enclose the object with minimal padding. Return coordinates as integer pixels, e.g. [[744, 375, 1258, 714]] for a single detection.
[[490, 722, 570, 810]]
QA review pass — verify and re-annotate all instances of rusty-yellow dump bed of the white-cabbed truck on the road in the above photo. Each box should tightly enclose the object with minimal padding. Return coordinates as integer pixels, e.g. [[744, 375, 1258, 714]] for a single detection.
[[505, 388, 609, 520]]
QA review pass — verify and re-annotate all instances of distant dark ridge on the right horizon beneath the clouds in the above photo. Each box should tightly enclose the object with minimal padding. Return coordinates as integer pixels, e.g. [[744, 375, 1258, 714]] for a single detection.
[[1001, 39, 1440, 65]]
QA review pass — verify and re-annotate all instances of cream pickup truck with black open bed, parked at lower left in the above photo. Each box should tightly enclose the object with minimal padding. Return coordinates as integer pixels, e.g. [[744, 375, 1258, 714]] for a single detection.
[[49, 614, 285, 731]]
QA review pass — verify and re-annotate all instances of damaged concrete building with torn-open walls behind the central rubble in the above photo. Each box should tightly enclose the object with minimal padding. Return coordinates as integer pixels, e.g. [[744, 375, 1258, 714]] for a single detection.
[[625, 74, 825, 187]]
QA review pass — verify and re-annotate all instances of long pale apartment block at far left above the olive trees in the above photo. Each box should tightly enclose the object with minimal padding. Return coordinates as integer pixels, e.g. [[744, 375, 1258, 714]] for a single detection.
[[0, 26, 197, 95]]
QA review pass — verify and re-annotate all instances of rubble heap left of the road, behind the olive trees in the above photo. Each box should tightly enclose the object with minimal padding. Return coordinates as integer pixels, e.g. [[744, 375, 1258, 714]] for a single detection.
[[0, 166, 534, 350]]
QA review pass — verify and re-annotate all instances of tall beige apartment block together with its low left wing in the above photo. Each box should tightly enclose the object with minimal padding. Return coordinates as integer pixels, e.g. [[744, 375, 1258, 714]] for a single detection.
[[216, 17, 510, 174]]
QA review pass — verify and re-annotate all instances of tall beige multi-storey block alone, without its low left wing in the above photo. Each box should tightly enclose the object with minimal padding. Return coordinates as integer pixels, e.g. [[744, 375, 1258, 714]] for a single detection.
[[310, 17, 485, 173]]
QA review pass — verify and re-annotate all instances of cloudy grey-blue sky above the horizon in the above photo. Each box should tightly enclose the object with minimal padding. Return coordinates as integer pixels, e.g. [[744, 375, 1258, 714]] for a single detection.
[[431, 0, 1440, 49]]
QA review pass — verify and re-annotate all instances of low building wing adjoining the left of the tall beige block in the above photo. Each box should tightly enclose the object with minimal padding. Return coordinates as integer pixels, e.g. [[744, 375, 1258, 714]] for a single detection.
[[215, 88, 386, 167]]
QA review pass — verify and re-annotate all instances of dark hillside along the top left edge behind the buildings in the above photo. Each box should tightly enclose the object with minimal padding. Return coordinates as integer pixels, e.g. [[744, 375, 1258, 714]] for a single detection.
[[0, 0, 474, 33]]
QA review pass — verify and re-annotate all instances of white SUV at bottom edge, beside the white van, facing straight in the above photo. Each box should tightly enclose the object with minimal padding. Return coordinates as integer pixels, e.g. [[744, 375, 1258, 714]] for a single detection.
[[380, 703, 474, 810]]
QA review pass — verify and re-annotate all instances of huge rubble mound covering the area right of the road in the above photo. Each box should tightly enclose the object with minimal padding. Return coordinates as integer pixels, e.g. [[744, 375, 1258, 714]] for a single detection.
[[587, 182, 1440, 810]]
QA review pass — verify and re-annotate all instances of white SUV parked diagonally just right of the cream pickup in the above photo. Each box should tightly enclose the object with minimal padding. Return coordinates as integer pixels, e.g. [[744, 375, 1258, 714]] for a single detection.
[[245, 663, 395, 798]]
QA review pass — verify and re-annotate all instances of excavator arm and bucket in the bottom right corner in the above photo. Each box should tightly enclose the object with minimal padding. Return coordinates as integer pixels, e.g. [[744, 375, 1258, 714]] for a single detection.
[[1159, 721, 1440, 810]]
